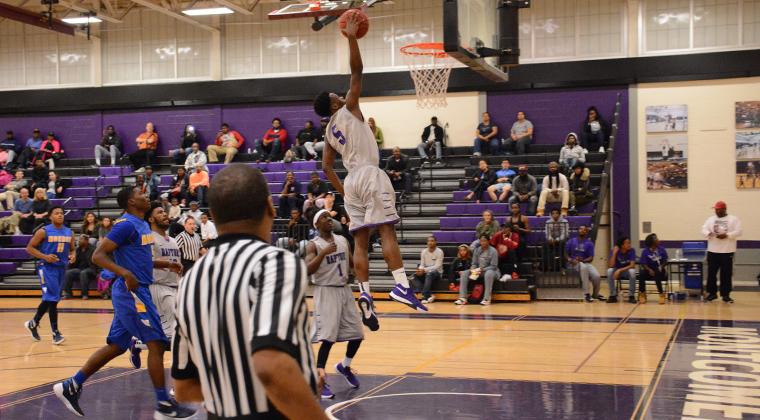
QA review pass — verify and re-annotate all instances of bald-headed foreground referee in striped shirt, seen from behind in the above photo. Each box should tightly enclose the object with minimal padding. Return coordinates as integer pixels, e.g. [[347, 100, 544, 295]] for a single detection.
[[172, 164, 326, 420]]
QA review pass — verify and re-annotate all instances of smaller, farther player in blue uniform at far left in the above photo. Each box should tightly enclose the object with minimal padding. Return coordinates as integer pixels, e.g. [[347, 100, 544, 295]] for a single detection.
[[24, 207, 76, 345]]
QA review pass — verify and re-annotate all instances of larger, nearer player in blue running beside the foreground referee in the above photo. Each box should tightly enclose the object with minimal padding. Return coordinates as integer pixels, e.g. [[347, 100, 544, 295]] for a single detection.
[[53, 187, 194, 419]]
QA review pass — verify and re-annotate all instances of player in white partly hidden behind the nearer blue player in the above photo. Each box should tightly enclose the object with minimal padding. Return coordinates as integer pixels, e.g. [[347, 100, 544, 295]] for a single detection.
[[146, 203, 182, 340]]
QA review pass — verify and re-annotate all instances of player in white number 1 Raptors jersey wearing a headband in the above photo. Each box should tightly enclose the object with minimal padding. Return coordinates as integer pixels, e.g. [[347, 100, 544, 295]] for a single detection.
[[306, 210, 364, 399]]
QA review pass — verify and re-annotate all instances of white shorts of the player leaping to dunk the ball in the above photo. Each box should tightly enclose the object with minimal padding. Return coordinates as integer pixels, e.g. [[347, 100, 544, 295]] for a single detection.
[[343, 165, 400, 232]]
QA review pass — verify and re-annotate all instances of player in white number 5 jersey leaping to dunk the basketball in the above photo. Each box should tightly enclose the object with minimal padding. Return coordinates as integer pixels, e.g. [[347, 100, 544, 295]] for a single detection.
[[314, 12, 427, 331]]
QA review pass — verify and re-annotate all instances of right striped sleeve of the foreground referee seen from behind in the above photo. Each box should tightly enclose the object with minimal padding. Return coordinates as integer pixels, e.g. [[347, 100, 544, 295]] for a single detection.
[[250, 250, 307, 359]]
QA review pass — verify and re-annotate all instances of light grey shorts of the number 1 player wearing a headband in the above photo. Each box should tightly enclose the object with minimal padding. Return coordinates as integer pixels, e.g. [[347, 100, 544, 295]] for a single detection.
[[311, 285, 364, 343]]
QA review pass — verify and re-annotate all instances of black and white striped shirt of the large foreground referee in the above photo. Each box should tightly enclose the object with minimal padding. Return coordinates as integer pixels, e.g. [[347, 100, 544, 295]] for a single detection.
[[172, 235, 317, 419]]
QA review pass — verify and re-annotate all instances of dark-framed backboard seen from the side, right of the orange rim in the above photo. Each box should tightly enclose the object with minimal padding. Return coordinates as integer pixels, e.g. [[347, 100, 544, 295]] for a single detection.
[[443, 0, 530, 82]]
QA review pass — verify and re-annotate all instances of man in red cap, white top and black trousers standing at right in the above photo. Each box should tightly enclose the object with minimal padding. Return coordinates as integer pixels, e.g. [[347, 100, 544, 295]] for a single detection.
[[702, 201, 742, 303]]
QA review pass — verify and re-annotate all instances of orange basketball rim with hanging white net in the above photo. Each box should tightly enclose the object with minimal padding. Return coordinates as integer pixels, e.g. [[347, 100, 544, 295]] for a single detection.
[[401, 42, 454, 108]]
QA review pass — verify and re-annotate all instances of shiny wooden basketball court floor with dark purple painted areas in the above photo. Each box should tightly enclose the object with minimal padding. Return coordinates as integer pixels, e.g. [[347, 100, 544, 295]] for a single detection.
[[0, 292, 760, 419]]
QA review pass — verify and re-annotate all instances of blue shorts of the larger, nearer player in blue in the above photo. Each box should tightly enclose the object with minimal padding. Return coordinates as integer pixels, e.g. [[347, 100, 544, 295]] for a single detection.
[[106, 278, 169, 350]]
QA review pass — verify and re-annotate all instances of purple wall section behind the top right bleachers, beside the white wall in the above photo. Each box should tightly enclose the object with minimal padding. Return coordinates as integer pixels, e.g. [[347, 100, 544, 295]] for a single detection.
[[487, 86, 631, 238]]
